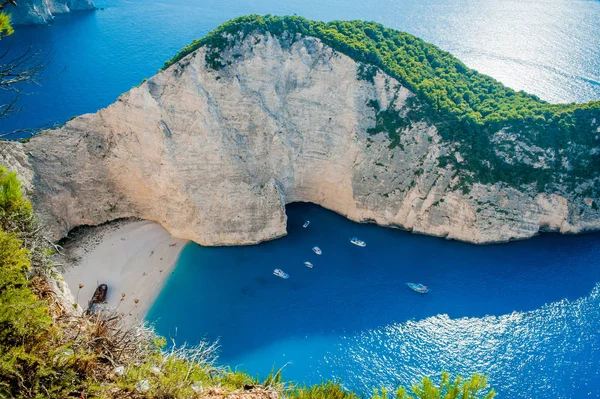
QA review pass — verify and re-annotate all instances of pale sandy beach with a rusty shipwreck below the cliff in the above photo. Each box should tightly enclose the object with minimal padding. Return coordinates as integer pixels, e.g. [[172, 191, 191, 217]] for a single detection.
[[62, 220, 188, 320]]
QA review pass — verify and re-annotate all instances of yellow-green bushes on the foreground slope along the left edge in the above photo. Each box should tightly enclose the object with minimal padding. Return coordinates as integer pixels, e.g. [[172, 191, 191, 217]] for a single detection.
[[0, 167, 89, 398]]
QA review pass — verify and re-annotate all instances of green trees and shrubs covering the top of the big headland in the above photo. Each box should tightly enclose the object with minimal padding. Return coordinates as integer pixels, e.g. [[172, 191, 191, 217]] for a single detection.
[[163, 15, 600, 193]]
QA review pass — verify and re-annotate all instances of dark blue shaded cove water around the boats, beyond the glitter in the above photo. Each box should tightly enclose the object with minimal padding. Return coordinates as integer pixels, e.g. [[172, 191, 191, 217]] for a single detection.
[[148, 204, 600, 361]]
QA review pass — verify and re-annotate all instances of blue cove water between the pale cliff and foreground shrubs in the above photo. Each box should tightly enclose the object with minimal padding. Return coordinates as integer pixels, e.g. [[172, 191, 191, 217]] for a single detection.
[[147, 204, 600, 398]]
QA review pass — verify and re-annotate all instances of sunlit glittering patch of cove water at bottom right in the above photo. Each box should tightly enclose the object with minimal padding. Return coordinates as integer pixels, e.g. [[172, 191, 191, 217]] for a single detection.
[[318, 284, 600, 399]]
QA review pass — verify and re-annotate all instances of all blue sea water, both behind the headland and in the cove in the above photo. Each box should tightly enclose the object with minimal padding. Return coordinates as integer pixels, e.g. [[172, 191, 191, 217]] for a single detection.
[[0, 0, 600, 399]]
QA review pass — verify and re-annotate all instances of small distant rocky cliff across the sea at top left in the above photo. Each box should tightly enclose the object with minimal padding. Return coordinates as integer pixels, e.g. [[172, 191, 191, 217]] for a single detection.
[[5, 0, 95, 25]]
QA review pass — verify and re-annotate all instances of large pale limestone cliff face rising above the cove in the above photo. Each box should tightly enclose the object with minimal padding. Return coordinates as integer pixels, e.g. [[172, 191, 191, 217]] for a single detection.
[[0, 35, 600, 245]]
